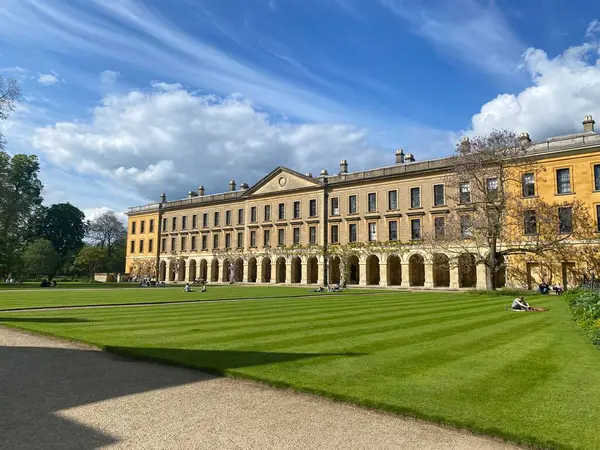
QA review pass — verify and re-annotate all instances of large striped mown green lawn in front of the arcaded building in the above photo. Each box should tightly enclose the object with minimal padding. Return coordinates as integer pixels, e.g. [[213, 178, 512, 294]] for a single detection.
[[0, 287, 600, 449]]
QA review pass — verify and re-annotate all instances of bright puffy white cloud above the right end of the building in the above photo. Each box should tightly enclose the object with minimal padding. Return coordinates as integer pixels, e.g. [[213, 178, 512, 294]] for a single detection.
[[471, 44, 600, 140]]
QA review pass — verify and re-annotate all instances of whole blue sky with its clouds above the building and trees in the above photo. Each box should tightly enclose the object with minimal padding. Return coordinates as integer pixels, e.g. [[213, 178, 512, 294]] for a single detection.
[[0, 0, 600, 215]]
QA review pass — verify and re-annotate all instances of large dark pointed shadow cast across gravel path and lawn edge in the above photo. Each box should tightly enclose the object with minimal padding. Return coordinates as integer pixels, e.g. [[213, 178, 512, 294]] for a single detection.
[[0, 342, 360, 450]]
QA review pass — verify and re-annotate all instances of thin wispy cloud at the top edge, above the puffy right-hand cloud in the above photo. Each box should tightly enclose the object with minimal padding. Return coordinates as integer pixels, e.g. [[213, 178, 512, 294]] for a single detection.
[[379, 0, 526, 75]]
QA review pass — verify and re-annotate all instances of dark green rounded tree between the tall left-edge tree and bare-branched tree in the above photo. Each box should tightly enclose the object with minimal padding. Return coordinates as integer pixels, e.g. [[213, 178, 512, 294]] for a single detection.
[[37, 203, 86, 257]]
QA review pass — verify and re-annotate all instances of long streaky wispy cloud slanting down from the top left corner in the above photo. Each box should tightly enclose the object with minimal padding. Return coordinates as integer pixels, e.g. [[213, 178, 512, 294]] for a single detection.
[[0, 0, 356, 120]]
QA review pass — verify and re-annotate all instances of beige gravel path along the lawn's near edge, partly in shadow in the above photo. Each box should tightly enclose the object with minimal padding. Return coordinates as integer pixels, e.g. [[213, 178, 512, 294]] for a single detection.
[[0, 327, 517, 450]]
